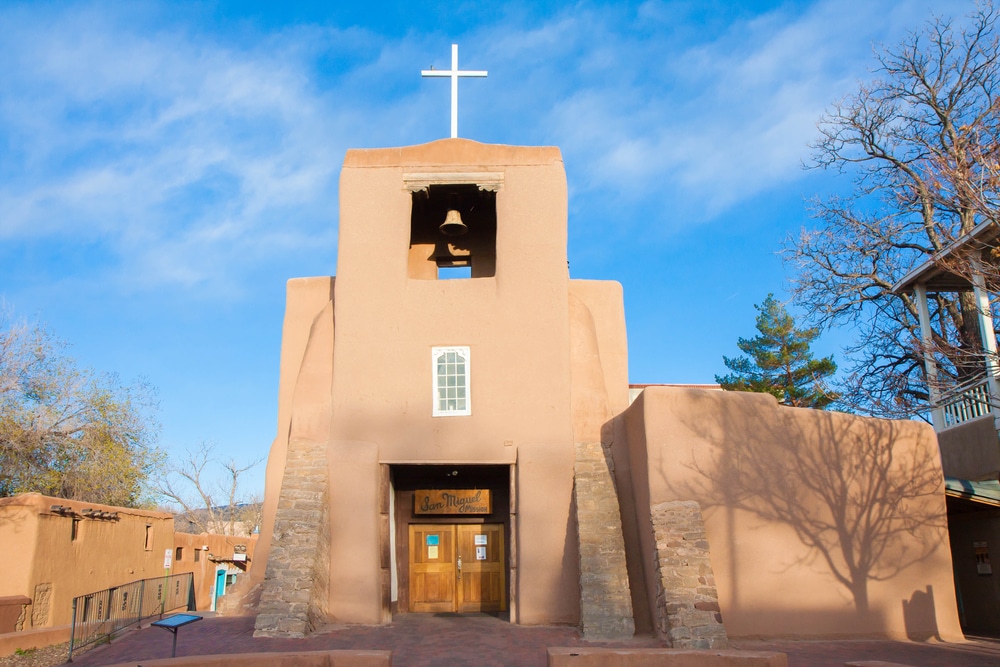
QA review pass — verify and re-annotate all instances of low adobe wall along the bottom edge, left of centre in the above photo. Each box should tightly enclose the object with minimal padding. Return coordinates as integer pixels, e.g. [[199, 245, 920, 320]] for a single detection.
[[105, 651, 392, 667]]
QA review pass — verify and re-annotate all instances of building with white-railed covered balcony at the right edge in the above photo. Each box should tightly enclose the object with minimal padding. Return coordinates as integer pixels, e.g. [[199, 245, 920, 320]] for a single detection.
[[893, 220, 1000, 635]]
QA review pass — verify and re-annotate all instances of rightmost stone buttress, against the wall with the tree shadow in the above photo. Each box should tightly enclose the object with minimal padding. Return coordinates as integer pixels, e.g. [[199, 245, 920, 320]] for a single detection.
[[651, 500, 729, 649]]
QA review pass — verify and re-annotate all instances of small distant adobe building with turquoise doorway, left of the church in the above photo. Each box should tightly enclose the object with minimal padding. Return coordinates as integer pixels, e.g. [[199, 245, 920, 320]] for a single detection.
[[170, 533, 257, 611]]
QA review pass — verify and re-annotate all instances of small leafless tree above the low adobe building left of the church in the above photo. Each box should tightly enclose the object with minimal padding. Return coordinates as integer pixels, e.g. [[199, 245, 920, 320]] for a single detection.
[[157, 442, 263, 535]]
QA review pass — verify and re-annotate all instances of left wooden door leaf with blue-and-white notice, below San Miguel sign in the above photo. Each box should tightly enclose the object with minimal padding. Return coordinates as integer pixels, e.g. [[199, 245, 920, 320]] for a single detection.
[[410, 524, 456, 612]]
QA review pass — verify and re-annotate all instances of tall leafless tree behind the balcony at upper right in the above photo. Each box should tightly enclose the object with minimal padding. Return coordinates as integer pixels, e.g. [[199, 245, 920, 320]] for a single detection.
[[785, 4, 1000, 416]]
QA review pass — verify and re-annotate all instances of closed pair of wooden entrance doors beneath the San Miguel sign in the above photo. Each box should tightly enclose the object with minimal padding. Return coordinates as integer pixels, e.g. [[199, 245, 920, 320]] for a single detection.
[[409, 523, 507, 612]]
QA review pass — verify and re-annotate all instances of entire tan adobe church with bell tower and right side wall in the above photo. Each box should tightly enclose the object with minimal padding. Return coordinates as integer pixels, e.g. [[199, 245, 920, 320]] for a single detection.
[[244, 139, 960, 648]]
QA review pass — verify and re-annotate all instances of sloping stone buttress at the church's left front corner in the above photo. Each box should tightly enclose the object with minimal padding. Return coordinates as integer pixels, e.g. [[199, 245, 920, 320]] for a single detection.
[[254, 440, 330, 637]]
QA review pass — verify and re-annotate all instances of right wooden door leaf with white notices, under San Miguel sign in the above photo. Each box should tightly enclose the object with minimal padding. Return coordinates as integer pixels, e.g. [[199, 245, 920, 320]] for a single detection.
[[456, 524, 507, 612]]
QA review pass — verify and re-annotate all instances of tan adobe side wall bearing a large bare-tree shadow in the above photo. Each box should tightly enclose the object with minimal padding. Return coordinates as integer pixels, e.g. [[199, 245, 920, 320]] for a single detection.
[[615, 387, 962, 640]]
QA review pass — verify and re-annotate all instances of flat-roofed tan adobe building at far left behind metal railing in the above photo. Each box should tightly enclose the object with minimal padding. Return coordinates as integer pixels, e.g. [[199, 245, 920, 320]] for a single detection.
[[0, 493, 174, 630]]
